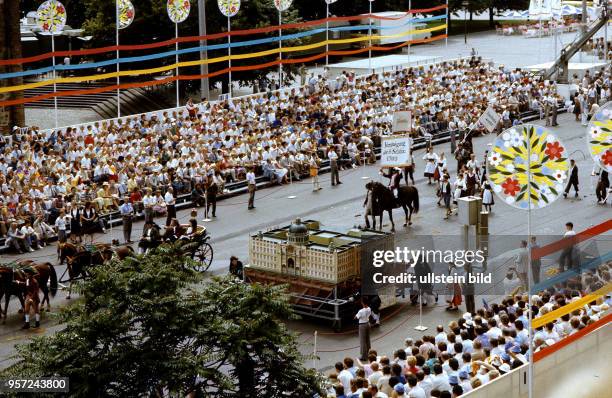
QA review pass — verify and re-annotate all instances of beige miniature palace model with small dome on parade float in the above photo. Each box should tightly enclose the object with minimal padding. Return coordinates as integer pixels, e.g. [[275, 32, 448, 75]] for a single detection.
[[249, 219, 394, 283]]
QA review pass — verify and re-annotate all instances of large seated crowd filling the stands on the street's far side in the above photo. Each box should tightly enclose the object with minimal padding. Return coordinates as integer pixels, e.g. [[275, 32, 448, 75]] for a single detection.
[[0, 57, 584, 250]]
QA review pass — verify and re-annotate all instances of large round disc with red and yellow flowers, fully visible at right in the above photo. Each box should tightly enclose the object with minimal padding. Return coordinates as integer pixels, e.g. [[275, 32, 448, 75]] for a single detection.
[[487, 124, 569, 210]]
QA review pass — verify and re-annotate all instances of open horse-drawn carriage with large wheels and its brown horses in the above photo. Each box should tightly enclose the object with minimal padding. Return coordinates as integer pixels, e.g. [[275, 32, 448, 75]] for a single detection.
[[58, 226, 213, 298]]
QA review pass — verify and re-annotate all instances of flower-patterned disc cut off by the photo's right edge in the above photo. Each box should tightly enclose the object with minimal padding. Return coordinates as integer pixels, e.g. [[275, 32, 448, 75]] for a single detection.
[[587, 102, 612, 173]]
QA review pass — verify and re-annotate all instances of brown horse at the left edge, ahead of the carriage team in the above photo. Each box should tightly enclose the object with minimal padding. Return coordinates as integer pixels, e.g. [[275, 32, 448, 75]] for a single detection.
[[0, 260, 58, 324]]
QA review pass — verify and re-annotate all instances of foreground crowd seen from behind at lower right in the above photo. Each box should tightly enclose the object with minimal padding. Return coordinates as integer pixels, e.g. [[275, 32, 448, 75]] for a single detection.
[[327, 262, 612, 398]]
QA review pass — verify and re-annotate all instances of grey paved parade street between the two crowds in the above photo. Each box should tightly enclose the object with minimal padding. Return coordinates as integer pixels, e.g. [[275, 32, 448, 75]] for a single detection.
[[0, 111, 612, 368]]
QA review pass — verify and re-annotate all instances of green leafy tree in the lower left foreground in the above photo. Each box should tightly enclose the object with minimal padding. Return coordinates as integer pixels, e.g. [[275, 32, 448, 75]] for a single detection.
[[2, 247, 326, 397]]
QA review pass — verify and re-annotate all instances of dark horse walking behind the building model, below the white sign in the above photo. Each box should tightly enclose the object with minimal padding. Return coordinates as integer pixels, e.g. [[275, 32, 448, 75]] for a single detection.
[[366, 181, 419, 232]]
